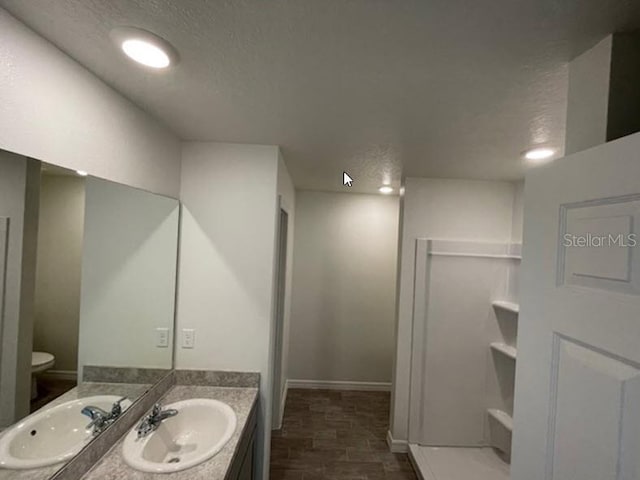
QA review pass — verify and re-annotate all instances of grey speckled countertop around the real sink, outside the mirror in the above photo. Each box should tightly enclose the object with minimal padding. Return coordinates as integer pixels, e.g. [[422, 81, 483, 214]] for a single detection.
[[82, 385, 258, 480]]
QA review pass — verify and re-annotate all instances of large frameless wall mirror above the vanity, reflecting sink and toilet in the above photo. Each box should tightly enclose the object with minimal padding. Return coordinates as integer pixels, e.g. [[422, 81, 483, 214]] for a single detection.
[[0, 151, 180, 480]]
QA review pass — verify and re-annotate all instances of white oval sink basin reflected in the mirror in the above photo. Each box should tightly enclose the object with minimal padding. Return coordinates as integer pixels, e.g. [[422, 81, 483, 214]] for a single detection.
[[0, 395, 131, 470]]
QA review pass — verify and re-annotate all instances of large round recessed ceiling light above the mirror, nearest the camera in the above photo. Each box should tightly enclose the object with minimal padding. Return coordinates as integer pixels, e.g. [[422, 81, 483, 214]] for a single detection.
[[110, 27, 178, 70]]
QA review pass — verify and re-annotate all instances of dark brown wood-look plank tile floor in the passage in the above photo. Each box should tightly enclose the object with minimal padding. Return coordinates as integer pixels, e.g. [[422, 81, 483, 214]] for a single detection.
[[271, 390, 416, 480]]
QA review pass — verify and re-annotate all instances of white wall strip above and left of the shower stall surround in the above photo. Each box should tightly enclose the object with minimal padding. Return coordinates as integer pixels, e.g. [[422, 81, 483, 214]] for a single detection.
[[391, 178, 517, 441]]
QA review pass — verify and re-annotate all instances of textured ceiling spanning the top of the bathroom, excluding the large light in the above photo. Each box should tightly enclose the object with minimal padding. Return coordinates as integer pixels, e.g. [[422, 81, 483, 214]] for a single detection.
[[0, 0, 640, 192]]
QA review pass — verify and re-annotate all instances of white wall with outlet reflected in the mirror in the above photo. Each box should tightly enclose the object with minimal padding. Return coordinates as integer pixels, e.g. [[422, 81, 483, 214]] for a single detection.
[[78, 178, 179, 378]]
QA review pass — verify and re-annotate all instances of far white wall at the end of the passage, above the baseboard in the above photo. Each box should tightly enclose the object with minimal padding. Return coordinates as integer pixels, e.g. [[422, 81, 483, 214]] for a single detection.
[[288, 191, 398, 383]]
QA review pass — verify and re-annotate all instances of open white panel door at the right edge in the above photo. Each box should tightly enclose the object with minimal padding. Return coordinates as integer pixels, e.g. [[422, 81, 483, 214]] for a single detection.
[[511, 135, 640, 480]]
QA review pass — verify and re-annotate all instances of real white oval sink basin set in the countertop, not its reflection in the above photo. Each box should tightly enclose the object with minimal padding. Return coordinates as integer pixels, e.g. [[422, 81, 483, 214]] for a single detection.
[[122, 399, 236, 473]]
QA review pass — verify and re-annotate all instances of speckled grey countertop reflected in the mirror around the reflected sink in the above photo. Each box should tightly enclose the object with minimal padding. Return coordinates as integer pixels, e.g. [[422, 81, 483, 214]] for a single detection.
[[0, 382, 151, 480]]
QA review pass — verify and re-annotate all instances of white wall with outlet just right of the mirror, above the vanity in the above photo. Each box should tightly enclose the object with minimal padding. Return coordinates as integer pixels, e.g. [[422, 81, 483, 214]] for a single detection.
[[175, 142, 279, 476]]
